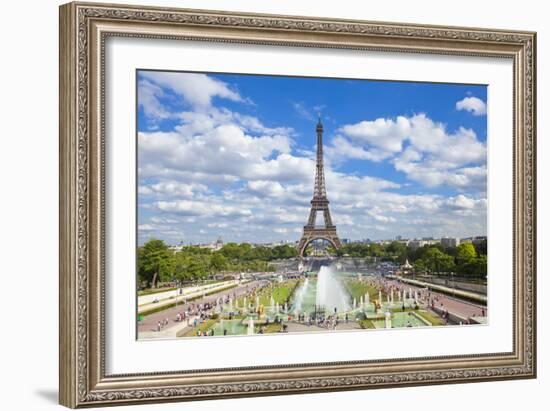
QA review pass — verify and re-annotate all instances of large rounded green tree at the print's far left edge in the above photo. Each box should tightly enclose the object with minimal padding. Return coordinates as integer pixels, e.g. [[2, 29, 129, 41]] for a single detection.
[[137, 240, 175, 288]]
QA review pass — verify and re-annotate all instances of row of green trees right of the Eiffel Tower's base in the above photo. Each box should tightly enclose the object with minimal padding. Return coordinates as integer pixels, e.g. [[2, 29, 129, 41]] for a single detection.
[[335, 240, 487, 278]]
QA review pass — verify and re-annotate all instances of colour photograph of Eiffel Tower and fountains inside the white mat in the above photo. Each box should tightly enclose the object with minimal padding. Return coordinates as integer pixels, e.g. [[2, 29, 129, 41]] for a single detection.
[[136, 68, 491, 340]]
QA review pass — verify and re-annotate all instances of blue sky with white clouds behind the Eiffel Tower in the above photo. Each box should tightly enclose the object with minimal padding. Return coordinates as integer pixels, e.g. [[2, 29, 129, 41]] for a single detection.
[[137, 71, 487, 244]]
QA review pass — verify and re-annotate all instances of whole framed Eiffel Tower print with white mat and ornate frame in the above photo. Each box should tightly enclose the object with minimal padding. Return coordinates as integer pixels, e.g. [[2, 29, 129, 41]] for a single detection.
[[60, 3, 536, 407]]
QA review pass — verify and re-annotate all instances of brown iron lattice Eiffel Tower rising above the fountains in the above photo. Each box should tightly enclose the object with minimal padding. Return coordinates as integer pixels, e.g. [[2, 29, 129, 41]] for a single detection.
[[298, 118, 342, 257]]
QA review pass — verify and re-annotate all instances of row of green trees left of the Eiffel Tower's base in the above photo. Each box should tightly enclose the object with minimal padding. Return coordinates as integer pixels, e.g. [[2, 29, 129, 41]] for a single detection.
[[137, 240, 298, 286]]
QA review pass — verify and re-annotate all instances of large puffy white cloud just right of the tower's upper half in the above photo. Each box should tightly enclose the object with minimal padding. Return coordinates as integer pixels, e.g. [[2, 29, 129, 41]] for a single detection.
[[327, 114, 487, 190]]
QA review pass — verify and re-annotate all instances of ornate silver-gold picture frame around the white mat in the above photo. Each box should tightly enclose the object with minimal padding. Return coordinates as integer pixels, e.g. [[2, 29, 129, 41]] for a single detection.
[[59, 3, 536, 408]]
